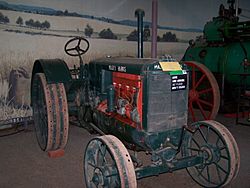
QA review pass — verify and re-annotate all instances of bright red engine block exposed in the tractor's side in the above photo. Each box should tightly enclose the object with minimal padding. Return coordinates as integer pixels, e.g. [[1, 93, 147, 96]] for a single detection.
[[97, 72, 142, 129]]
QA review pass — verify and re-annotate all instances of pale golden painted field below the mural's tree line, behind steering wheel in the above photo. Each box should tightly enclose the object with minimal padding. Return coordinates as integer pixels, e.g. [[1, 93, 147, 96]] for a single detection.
[[0, 30, 188, 78]]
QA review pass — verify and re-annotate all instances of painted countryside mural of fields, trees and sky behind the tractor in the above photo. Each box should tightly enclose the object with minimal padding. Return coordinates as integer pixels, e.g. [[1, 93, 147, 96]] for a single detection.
[[0, 0, 250, 119]]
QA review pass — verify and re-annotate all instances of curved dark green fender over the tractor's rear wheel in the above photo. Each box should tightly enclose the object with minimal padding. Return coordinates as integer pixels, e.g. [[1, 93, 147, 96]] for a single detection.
[[31, 59, 72, 104]]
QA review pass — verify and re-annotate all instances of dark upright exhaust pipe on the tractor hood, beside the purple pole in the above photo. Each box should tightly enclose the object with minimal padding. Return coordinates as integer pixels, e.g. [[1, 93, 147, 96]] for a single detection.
[[135, 9, 145, 58]]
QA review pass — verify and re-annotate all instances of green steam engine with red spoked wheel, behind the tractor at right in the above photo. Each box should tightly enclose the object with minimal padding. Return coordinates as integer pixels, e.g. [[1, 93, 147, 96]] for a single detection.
[[182, 0, 250, 117]]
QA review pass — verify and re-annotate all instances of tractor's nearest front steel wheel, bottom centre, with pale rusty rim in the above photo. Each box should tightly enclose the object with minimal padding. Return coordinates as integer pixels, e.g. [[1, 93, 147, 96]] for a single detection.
[[84, 135, 137, 188]]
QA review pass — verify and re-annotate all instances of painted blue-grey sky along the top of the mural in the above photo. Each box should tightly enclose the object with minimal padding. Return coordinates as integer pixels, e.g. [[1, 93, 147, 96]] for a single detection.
[[7, 0, 250, 28]]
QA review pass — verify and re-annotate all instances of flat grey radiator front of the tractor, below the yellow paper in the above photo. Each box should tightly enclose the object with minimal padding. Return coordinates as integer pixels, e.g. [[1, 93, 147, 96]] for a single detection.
[[147, 73, 188, 132]]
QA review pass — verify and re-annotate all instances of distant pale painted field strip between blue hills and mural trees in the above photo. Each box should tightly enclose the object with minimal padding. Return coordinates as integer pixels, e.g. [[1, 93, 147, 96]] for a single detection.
[[0, 10, 201, 40]]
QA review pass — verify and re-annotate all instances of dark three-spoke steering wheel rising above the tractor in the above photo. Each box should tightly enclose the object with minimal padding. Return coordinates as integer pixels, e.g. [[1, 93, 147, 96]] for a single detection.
[[64, 37, 89, 56]]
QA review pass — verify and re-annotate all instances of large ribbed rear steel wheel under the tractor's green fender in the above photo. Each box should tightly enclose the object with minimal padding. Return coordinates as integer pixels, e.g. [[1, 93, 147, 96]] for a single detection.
[[32, 73, 69, 151]]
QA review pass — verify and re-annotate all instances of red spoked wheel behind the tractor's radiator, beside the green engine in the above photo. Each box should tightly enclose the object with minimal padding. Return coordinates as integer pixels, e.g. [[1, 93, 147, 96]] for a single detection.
[[183, 61, 220, 122]]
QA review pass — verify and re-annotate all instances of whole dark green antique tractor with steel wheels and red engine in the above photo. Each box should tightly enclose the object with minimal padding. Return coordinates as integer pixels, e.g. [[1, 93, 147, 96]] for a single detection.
[[31, 9, 240, 188]]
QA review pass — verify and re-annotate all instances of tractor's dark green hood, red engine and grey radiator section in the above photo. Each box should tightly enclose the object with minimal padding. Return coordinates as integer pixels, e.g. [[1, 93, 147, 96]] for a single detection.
[[89, 58, 188, 148]]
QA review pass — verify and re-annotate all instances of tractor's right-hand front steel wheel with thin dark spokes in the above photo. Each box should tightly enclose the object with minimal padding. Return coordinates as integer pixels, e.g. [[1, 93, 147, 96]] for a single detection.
[[183, 120, 240, 187]]
